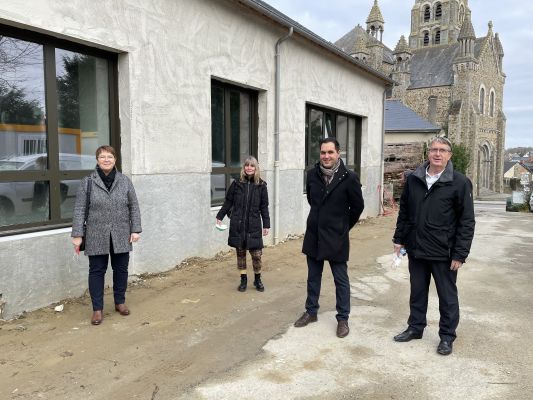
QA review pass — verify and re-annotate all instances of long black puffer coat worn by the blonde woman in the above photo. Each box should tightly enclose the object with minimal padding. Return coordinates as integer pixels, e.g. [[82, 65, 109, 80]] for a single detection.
[[216, 180, 270, 250]]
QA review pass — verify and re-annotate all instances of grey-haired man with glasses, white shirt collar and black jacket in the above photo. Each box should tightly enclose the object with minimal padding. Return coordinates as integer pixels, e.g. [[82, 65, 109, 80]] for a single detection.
[[393, 137, 475, 355]]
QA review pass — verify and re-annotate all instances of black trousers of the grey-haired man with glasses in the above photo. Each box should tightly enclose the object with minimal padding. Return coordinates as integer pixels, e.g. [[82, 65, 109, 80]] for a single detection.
[[407, 257, 459, 342]]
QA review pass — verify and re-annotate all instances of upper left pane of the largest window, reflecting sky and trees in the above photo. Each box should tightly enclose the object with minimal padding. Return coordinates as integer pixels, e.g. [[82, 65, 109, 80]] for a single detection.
[[0, 35, 47, 170]]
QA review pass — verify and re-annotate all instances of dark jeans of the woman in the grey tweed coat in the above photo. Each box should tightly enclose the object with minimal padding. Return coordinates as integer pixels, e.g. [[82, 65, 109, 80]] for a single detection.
[[89, 247, 130, 311]]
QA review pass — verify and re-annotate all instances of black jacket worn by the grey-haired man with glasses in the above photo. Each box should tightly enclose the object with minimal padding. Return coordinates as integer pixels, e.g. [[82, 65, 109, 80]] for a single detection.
[[393, 161, 476, 262]]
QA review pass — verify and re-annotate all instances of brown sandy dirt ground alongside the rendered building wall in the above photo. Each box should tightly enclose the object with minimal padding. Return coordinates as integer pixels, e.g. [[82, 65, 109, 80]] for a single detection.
[[0, 209, 531, 400]]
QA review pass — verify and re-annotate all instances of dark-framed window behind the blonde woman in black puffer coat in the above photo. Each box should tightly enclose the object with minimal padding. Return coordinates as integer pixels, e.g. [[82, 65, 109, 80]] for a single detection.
[[210, 80, 257, 206]]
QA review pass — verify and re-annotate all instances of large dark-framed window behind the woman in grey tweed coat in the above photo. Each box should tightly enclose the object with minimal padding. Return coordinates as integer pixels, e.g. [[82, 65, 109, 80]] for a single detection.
[[0, 25, 120, 235]]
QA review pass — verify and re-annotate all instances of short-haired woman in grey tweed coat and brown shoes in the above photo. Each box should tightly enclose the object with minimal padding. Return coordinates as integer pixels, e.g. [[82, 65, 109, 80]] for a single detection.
[[71, 146, 142, 325]]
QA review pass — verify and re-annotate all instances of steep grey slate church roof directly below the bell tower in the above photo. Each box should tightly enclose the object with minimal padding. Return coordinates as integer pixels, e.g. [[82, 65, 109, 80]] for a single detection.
[[409, 37, 486, 89]]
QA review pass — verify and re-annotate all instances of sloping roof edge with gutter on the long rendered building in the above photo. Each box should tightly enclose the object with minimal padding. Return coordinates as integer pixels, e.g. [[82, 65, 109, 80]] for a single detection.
[[238, 0, 394, 86]]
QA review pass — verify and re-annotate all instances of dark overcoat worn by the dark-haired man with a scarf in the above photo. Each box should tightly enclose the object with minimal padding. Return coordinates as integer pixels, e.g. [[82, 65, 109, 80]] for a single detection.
[[302, 160, 364, 262]]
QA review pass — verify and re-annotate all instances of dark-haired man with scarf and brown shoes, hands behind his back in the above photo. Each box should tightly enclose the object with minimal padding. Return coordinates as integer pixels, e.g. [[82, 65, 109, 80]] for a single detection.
[[294, 138, 364, 338]]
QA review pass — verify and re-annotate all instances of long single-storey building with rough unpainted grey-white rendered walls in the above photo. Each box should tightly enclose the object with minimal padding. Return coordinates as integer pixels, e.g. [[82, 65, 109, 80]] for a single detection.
[[0, 0, 392, 318]]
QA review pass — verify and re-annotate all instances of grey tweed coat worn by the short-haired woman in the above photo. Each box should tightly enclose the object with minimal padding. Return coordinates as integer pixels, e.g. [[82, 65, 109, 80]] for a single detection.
[[71, 170, 142, 256]]
